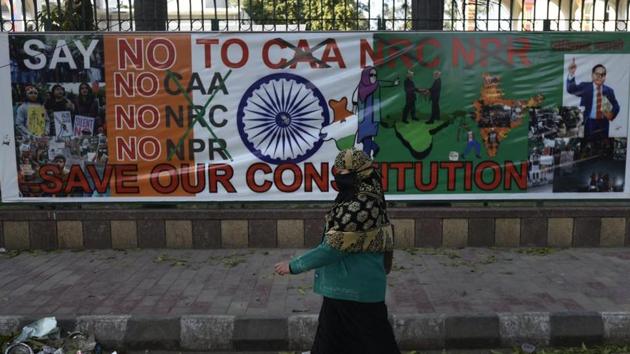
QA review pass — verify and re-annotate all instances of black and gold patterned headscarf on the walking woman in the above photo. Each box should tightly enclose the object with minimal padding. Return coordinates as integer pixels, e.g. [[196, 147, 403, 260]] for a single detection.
[[324, 148, 394, 252]]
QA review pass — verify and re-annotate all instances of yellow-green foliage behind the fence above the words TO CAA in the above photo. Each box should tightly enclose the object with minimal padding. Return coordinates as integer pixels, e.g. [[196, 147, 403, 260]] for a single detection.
[[242, 0, 369, 31]]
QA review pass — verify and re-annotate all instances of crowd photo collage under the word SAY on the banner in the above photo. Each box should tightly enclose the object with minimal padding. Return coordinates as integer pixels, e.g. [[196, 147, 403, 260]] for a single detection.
[[9, 35, 109, 197]]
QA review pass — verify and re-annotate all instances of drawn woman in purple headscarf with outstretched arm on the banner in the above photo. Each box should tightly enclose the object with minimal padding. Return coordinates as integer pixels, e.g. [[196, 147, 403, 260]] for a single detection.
[[353, 66, 398, 157]]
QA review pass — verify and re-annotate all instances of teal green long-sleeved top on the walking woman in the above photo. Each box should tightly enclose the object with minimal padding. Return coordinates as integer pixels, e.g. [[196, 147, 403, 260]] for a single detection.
[[289, 243, 387, 302]]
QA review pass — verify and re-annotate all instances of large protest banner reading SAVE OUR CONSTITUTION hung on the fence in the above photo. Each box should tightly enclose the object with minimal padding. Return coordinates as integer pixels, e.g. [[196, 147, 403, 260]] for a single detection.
[[0, 32, 630, 202]]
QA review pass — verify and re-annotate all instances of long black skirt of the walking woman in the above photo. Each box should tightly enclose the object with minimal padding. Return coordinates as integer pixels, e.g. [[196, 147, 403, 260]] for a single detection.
[[311, 297, 400, 354]]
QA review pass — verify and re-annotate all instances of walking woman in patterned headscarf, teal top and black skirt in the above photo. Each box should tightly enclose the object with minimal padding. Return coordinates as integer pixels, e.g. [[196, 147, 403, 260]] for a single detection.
[[275, 148, 400, 354]]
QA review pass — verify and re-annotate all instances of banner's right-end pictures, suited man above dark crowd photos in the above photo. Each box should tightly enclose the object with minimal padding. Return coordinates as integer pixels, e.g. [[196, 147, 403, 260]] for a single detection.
[[545, 54, 630, 192]]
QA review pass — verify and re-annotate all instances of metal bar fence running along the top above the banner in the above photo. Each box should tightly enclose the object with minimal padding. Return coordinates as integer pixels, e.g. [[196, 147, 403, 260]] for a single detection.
[[0, 0, 630, 32]]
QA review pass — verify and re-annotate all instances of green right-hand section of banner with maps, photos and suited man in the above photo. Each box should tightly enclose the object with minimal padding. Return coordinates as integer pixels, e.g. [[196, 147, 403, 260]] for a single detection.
[[372, 33, 630, 197]]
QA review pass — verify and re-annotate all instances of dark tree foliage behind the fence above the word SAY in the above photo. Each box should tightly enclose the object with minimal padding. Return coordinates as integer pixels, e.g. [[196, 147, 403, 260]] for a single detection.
[[37, 0, 95, 31]]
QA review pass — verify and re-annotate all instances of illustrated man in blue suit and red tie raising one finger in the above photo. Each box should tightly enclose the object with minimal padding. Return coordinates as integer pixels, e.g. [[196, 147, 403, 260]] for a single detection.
[[567, 58, 619, 140]]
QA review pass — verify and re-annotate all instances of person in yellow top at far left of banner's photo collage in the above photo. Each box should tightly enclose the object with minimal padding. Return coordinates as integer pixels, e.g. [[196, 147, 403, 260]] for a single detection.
[[15, 85, 50, 138]]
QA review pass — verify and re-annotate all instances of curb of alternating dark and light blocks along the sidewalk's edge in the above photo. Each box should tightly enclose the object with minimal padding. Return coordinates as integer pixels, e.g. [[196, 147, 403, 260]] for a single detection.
[[0, 312, 630, 352]]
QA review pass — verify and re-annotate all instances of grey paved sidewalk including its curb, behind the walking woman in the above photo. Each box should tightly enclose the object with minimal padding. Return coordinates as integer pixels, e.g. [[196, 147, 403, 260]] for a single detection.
[[0, 248, 630, 351]]
